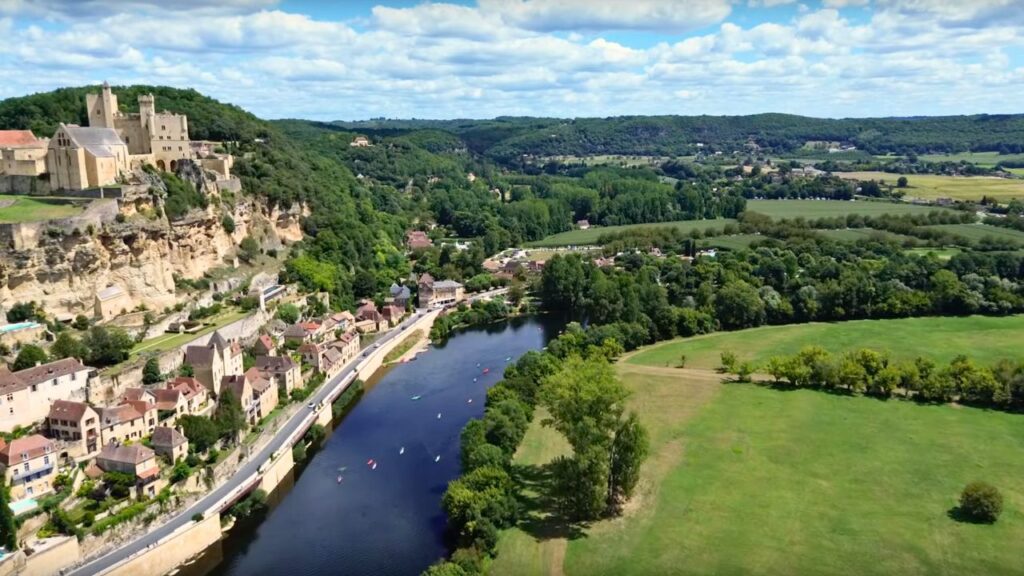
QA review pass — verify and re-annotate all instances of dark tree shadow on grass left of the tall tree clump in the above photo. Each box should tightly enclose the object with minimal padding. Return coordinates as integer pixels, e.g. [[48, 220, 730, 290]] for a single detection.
[[515, 464, 589, 540]]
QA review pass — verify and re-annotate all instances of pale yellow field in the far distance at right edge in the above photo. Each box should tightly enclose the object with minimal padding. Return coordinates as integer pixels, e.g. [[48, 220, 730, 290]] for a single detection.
[[837, 172, 1024, 202]]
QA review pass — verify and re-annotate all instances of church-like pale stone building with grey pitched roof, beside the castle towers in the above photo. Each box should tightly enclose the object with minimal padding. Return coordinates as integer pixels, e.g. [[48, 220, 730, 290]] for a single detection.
[[46, 124, 131, 190]]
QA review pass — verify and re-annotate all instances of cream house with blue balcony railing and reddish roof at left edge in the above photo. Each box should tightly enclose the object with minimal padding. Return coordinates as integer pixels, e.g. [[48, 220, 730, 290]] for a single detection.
[[0, 434, 57, 501]]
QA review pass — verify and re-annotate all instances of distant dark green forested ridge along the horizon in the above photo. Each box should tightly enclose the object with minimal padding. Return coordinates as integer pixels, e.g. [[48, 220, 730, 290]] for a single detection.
[[334, 114, 1024, 158]]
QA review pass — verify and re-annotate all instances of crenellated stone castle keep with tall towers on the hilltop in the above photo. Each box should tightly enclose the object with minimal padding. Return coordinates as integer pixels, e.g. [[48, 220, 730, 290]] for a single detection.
[[85, 82, 193, 172]]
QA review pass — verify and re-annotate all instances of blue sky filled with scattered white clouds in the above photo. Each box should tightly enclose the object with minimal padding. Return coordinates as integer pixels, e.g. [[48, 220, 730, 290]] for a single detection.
[[0, 0, 1024, 121]]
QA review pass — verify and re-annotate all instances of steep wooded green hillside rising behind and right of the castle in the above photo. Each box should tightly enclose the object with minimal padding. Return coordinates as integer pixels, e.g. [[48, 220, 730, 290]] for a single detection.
[[0, 86, 413, 306]]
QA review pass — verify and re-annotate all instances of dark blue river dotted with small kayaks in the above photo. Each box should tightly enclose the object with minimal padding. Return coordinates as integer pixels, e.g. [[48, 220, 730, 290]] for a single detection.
[[179, 317, 564, 576]]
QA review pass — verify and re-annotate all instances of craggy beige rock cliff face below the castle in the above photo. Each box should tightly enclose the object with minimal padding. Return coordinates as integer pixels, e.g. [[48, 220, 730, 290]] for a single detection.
[[0, 165, 301, 318]]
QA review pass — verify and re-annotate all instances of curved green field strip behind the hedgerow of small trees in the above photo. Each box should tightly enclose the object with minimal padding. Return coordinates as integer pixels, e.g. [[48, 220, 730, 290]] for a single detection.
[[626, 315, 1024, 369]]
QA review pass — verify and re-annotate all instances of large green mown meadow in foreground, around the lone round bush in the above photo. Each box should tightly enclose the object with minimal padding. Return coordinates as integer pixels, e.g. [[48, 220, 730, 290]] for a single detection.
[[490, 318, 1024, 576]]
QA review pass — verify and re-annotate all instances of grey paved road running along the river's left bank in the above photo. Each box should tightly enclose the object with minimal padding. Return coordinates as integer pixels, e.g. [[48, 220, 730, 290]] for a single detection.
[[68, 311, 436, 576]]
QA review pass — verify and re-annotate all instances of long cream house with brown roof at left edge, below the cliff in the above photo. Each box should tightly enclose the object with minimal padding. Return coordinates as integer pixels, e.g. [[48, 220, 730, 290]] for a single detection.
[[0, 358, 92, 431]]
